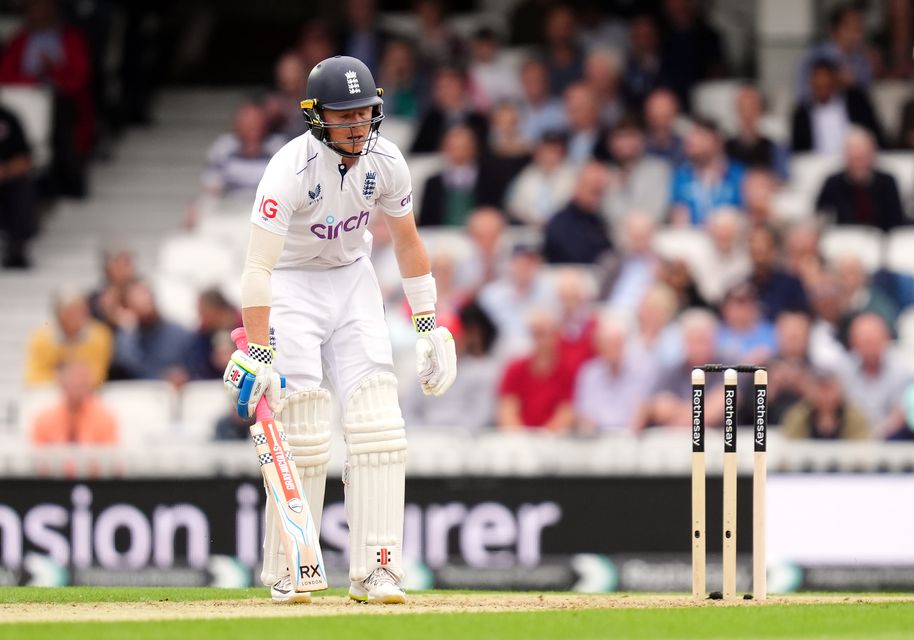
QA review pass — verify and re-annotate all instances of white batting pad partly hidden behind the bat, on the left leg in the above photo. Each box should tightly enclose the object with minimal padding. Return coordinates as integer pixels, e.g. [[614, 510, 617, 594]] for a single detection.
[[260, 389, 330, 586]]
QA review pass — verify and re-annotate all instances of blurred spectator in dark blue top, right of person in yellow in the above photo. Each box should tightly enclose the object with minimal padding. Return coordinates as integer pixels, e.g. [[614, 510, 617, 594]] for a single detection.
[[112, 282, 191, 387]]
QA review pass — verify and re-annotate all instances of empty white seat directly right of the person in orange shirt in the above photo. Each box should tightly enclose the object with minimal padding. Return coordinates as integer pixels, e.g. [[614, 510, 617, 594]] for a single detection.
[[101, 380, 180, 448]]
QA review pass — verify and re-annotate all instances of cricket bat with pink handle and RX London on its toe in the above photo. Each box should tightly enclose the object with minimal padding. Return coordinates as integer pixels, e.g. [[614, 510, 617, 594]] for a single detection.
[[232, 327, 328, 591]]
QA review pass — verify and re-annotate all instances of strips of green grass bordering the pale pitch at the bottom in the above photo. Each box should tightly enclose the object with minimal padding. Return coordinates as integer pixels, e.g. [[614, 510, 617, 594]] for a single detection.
[[0, 587, 914, 640]]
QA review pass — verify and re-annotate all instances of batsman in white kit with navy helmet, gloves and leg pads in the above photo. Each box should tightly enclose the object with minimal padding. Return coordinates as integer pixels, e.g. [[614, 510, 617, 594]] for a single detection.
[[225, 56, 457, 603]]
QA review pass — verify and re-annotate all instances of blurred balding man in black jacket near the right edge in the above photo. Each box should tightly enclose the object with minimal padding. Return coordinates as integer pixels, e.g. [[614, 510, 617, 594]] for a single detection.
[[816, 128, 906, 231]]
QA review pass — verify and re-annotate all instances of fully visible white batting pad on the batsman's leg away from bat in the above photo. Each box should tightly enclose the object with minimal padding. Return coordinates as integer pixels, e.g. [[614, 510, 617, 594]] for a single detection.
[[343, 373, 406, 582]]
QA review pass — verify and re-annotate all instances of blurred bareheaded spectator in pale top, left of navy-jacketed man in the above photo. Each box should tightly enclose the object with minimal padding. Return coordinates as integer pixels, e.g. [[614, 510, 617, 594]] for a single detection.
[[454, 207, 508, 295]]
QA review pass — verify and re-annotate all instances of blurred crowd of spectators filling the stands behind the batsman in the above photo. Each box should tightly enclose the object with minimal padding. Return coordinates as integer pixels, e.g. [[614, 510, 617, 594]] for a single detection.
[[17, 0, 914, 439]]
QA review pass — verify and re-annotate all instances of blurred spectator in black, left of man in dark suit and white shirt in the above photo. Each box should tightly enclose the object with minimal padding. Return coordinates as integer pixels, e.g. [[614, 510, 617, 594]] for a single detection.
[[726, 85, 787, 177]]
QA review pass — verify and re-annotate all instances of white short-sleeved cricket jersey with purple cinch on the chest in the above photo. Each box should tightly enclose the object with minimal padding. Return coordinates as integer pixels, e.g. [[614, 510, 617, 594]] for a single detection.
[[251, 131, 412, 269]]
